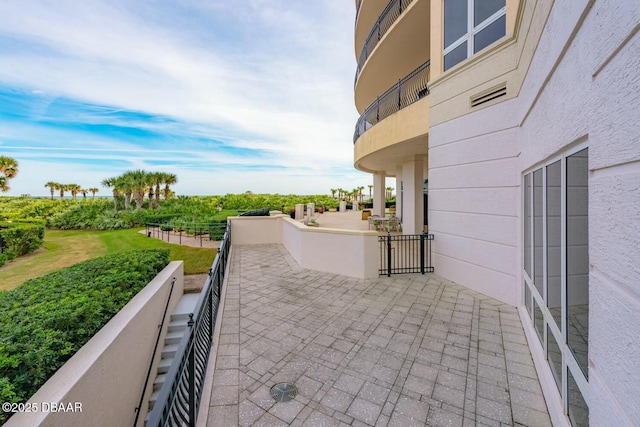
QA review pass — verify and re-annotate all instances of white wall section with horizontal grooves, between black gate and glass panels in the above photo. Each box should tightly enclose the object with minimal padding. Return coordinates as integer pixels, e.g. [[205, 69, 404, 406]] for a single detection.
[[429, 100, 520, 305]]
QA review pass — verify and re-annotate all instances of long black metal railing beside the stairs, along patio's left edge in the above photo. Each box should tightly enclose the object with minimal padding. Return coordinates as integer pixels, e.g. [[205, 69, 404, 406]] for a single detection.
[[146, 225, 231, 427]]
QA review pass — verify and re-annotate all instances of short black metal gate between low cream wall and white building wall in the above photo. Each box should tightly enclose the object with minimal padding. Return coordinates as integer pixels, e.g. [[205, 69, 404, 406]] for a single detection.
[[378, 233, 434, 276]]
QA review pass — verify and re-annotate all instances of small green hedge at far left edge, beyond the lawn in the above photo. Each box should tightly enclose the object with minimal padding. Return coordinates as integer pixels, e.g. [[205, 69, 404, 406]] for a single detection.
[[0, 222, 44, 266]]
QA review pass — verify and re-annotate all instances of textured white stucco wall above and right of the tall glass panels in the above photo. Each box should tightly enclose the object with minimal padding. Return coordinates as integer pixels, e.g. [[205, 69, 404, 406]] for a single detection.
[[518, 0, 640, 426]]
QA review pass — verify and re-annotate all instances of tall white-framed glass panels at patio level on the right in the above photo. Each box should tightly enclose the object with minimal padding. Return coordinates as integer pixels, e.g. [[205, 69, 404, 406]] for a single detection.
[[522, 148, 589, 426]]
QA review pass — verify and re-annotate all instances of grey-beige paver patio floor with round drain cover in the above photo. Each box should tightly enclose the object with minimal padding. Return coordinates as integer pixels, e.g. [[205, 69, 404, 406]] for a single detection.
[[202, 245, 551, 427]]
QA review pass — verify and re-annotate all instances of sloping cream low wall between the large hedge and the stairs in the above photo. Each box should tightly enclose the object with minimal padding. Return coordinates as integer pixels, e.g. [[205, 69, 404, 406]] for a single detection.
[[5, 261, 183, 427]]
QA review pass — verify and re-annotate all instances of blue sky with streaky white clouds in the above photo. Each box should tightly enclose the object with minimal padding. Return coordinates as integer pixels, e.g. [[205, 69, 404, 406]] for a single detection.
[[0, 0, 372, 196]]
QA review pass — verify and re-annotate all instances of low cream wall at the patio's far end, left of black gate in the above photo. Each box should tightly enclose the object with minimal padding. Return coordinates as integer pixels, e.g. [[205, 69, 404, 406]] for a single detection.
[[229, 215, 378, 279]]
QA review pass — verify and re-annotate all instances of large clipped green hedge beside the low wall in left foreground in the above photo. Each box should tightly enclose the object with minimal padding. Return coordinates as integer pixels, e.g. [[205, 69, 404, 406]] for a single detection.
[[0, 249, 169, 424]]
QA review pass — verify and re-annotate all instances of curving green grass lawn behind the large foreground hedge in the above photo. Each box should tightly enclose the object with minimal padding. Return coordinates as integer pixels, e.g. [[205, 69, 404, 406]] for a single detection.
[[0, 228, 217, 291]]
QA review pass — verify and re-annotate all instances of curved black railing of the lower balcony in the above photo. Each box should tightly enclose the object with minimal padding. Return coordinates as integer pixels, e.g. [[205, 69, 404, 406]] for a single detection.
[[353, 60, 430, 144]]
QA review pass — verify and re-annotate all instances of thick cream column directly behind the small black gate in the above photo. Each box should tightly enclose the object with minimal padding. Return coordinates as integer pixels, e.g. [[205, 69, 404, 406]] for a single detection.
[[402, 157, 424, 234]]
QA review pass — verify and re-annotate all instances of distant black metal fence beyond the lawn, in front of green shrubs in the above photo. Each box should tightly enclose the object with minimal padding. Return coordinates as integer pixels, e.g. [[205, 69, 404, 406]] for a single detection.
[[145, 221, 227, 247]]
